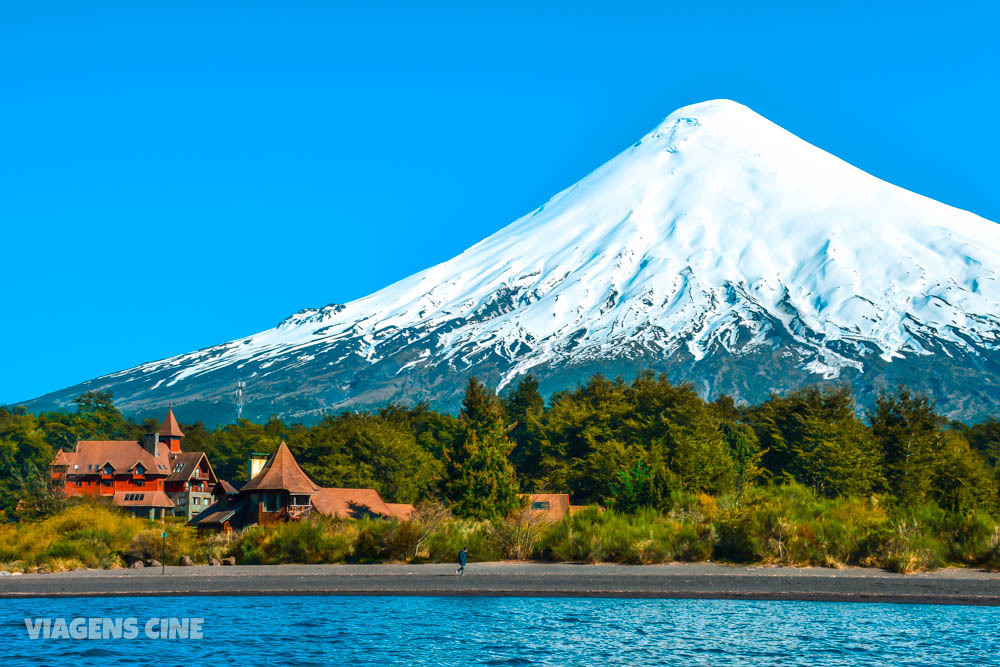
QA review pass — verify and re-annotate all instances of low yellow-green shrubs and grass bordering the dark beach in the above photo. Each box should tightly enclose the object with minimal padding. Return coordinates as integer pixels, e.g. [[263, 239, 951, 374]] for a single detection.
[[0, 484, 1000, 572]]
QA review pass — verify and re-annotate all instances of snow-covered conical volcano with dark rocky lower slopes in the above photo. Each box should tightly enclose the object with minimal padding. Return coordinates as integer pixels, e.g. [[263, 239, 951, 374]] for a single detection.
[[19, 100, 1000, 422]]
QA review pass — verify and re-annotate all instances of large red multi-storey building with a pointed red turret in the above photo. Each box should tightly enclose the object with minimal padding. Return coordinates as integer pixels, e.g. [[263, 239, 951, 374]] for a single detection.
[[50, 408, 225, 519]]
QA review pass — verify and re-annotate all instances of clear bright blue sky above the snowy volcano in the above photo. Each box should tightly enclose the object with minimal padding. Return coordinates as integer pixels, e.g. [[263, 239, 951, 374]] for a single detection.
[[0, 0, 1000, 403]]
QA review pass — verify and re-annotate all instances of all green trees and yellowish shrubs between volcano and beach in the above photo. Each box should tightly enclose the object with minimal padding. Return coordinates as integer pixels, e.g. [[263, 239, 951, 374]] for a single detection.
[[0, 373, 1000, 573]]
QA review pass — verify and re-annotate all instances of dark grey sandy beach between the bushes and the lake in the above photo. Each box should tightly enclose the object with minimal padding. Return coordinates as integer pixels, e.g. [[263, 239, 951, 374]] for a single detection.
[[0, 562, 1000, 605]]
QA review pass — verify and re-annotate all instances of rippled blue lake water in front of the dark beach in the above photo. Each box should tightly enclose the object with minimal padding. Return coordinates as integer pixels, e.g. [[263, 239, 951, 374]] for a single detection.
[[0, 596, 1000, 667]]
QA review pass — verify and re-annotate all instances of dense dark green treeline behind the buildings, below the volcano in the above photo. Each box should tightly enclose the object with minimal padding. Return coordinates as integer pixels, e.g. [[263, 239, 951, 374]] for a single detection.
[[0, 374, 1000, 519]]
